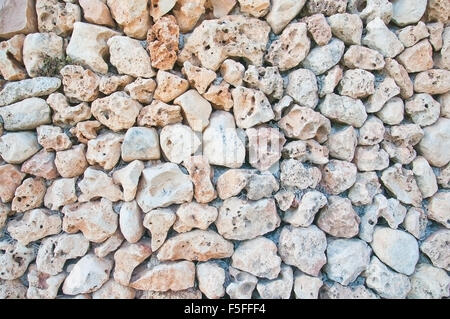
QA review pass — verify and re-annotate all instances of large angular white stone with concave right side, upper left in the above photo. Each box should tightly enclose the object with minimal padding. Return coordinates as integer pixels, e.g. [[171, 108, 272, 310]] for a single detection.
[[66, 22, 118, 74]]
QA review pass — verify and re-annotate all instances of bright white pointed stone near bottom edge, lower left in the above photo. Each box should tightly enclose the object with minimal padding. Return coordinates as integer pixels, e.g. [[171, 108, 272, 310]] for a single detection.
[[62, 254, 113, 295]]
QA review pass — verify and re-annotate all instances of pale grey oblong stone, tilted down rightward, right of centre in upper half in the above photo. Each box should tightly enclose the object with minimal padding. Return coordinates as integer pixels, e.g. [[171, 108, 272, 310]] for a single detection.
[[319, 93, 367, 127]]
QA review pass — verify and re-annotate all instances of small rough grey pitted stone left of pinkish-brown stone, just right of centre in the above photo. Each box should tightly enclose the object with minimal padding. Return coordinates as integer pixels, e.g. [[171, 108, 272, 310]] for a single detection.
[[280, 159, 322, 190]]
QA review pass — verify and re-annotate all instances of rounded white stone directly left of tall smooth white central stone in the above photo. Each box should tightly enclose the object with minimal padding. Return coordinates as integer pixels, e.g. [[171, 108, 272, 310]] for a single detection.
[[160, 124, 202, 164]]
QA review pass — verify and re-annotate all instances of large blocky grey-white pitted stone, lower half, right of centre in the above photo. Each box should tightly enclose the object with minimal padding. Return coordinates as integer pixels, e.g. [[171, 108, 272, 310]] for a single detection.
[[278, 225, 327, 276]]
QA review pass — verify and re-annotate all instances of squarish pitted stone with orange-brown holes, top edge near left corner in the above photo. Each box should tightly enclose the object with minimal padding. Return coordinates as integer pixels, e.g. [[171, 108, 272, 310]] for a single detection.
[[36, 0, 81, 36]]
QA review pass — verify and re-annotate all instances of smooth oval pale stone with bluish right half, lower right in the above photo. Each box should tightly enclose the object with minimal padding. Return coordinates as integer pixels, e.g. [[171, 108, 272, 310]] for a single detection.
[[371, 226, 419, 275]]
